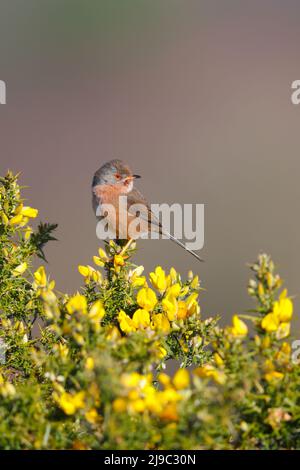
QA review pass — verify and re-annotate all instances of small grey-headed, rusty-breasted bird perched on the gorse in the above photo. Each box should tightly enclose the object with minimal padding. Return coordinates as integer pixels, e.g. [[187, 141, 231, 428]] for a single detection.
[[92, 160, 203, 261]]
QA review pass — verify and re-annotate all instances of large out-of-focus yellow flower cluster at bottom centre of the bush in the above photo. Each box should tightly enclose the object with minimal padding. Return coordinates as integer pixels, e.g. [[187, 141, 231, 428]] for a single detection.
[[113, 369, 190, 421]]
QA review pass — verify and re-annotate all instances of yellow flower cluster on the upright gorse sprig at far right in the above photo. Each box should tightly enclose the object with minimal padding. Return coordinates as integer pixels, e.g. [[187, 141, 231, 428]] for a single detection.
[[261, 289, 293, 339]]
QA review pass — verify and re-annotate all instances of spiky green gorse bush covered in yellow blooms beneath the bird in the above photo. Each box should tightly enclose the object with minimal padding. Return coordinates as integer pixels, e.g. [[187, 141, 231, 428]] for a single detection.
[[0, 173, 300, 449]]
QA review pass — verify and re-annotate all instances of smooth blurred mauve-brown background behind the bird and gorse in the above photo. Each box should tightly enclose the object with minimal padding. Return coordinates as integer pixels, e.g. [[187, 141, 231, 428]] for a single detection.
[[0, 0, 300, 330]]
